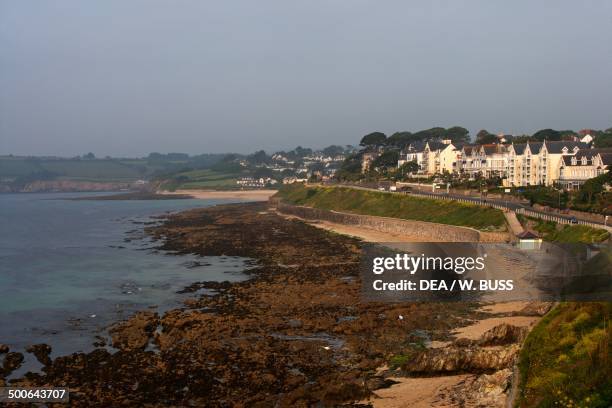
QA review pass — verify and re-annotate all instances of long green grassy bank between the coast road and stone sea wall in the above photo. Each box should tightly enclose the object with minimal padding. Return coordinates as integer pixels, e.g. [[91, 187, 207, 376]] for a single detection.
[[279, 185, 505, 231]]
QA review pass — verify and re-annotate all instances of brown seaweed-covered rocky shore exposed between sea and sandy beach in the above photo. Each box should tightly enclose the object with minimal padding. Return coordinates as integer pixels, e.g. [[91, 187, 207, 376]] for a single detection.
[[0, 203, 544, 407]]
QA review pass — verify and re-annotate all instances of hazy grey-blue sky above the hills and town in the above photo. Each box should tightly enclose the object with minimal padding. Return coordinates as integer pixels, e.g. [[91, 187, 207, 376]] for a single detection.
[[0, 0, 612, 157]]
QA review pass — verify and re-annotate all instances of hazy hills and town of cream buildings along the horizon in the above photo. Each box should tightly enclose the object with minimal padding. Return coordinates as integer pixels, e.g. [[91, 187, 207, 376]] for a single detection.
[[0, 126, 612, 214]]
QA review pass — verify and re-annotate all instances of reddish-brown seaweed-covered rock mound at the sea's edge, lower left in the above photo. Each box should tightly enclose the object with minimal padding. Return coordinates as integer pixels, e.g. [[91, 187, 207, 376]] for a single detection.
[[110, 311, 159, 351]]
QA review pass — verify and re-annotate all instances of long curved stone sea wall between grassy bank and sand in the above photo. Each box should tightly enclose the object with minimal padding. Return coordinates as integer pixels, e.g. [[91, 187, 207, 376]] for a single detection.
[[270, 198, 508, 242]]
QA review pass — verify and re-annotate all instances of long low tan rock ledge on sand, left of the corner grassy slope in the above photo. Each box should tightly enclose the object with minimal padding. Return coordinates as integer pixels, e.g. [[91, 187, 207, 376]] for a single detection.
[[402, 345, 518, 374]]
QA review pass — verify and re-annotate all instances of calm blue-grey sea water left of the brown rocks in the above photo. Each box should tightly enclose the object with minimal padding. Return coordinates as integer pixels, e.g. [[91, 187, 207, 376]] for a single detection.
[[0, 193, 248, 371]]
